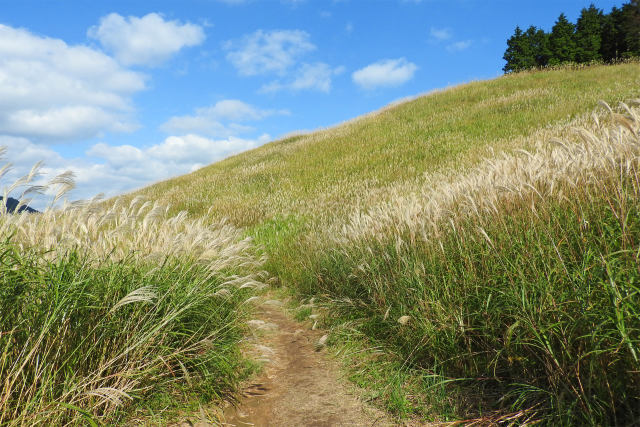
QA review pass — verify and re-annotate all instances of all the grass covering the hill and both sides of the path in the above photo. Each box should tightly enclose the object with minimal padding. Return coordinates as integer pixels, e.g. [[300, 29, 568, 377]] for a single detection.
[[5, 62, 640, 425]]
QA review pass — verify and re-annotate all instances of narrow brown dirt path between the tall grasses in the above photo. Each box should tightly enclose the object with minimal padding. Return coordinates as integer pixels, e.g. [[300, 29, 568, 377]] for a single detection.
[[223, 301, 396, 427]]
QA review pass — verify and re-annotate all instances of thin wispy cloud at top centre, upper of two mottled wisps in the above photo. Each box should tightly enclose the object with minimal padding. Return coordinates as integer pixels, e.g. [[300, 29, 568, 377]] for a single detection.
[[224, 30, 316, 76]]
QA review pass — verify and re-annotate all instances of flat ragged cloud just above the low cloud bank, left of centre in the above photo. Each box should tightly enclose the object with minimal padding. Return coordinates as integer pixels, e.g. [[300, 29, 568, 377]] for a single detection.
[[161, 99, 290, 137]]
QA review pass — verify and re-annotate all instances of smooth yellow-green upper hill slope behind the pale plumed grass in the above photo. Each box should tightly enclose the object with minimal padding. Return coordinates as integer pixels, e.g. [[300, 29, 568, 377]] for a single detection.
[[135, 63, 640, 226]]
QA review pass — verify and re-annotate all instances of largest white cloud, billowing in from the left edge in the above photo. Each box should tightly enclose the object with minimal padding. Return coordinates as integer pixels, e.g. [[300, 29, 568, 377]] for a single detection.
[[0, 24, 145, 142]]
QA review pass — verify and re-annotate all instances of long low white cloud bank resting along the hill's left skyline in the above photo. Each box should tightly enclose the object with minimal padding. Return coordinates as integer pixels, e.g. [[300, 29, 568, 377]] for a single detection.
[[0, 134, 270, 204]]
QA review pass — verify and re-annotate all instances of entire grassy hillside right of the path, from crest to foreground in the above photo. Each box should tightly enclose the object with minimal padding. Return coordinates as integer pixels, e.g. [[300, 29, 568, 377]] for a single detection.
[[125, 63, 640, 425]]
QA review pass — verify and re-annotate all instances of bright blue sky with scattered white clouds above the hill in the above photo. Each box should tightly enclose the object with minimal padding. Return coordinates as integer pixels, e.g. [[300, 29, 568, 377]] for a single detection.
[[0, 0, 622, 204]]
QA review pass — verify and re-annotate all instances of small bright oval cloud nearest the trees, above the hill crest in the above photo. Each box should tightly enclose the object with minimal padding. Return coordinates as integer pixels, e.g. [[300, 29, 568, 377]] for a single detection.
[[351, 58, 418, 89]]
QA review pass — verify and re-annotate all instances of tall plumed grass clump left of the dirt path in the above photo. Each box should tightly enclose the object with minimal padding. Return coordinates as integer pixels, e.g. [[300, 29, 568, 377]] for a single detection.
[[0, 156, 264, 425]]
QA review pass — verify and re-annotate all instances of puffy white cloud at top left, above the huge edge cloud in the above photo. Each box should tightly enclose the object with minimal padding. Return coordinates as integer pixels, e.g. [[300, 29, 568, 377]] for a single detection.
[[87, 13, 205, 65]]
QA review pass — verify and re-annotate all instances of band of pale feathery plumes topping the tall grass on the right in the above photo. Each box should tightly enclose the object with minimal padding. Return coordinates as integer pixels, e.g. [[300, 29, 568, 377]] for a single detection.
[[336, 99, 640, 245]]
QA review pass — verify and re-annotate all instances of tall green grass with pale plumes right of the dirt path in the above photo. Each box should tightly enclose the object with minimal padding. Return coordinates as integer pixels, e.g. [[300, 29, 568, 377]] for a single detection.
[[294, 105, 640, 425]]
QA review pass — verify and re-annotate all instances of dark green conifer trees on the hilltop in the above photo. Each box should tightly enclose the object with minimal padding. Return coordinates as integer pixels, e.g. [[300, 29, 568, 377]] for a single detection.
[[503, 0, 640, 73]]
